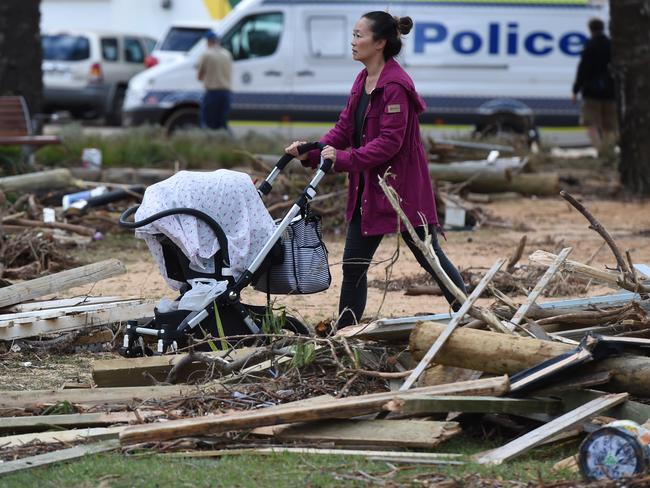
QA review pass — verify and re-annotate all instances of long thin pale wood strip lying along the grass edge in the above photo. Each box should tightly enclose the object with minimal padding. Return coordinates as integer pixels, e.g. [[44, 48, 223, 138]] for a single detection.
[[165, 446, 465, 465]]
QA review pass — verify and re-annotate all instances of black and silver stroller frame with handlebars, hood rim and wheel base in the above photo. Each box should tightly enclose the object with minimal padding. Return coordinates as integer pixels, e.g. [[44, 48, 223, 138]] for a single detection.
[[119, 142, 333, 357]]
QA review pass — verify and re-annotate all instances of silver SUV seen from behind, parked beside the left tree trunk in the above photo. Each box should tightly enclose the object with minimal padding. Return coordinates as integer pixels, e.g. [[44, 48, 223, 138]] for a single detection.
[[41, 31, 156, 125]]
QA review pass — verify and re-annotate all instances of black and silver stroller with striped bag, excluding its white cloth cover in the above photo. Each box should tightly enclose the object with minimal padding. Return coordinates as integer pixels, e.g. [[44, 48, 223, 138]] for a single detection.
[[119, 142, 332, 357]]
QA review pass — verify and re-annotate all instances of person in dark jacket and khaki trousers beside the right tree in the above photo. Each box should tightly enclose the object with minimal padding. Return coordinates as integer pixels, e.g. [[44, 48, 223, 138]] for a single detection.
[[573, 19, 618, 149]]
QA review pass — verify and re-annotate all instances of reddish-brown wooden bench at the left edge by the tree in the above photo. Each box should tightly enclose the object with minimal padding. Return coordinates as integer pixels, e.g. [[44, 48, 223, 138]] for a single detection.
[[0, 97, 61, 147]]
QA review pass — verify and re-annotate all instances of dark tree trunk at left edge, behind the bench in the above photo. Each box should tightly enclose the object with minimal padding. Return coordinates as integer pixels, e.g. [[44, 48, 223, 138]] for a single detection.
[[0, 0, 43, 114]]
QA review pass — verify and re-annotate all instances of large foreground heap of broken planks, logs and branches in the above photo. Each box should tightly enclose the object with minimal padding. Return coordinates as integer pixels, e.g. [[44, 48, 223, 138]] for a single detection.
[[0, 190, 650, 479]]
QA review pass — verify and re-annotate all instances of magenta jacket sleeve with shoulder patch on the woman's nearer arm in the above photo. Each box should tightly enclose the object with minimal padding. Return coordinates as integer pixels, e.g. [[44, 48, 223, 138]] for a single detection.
[[334, 83, 409, 172]]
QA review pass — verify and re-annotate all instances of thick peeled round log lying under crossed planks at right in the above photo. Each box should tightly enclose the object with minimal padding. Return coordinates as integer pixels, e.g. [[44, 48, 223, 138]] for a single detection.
[[409, 322, 650, 397]]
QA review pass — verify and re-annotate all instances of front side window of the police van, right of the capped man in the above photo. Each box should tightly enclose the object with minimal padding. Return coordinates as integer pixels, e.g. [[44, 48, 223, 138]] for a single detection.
[[221, 12, 283, 61]]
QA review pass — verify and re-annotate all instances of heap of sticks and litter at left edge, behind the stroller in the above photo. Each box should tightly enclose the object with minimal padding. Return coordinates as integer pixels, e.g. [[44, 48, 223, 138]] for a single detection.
[[0, 168, 144, 286]]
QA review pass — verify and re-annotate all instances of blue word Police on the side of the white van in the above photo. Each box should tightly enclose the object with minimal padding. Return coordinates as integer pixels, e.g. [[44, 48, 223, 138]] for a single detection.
[[414, 22, 587, 56]]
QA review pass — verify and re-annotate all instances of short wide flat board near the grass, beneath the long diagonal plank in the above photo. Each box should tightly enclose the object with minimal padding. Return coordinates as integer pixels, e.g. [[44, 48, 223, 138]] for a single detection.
[[251, 420, 461, 449]]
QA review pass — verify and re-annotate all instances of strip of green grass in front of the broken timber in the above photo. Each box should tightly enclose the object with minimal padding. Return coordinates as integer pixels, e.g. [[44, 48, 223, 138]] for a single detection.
[[0, 436, 578, 488]]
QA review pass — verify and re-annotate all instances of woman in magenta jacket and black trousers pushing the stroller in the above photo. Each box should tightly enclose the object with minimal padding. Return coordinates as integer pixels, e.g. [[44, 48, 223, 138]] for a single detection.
[[286, 11, 465, 328]]
